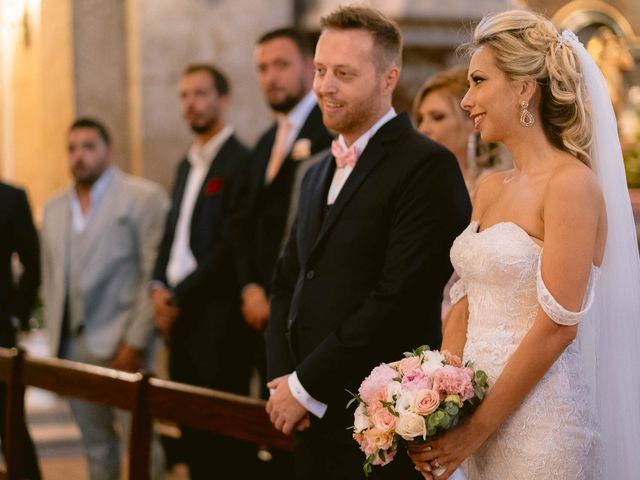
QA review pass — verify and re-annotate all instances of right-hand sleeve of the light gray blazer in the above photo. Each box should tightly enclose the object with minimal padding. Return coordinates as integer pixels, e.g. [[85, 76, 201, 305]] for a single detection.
[[124, 187, 168, 350]]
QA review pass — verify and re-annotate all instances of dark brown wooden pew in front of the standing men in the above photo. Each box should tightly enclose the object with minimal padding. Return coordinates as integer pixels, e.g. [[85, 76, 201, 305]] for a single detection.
[[0, 349, 293, 480]]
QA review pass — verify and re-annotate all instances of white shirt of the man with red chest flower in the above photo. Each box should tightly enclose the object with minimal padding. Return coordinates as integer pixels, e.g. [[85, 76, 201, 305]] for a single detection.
[[167, 125, 233, 288]]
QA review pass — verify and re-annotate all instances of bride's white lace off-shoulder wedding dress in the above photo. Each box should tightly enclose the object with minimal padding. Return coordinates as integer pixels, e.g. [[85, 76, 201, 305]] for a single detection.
[[451, 221, 602, 480]]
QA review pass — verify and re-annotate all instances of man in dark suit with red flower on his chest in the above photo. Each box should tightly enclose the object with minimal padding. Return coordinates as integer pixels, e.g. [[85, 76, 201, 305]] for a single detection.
[[152, 65, 252, 480]]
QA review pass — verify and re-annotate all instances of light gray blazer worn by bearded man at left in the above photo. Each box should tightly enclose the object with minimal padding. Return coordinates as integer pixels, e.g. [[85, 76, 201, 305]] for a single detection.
[[42, 169, 168, 359]]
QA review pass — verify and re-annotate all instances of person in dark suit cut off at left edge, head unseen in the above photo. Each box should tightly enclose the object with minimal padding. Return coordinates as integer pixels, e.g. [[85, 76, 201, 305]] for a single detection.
[[0, 182, 40, 480]]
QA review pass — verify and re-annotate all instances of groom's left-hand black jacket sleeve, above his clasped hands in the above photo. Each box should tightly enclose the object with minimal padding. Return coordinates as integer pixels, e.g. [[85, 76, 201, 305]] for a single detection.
[[265, 220, 300, 380]]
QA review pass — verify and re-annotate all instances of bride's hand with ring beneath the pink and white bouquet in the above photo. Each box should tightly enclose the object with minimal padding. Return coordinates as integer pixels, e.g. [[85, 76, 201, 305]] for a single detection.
[[408, 422, 485, 480]]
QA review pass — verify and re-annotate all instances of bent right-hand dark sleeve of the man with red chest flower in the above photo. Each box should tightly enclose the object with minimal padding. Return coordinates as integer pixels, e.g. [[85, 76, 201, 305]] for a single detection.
[[174, 149, 249, 305]]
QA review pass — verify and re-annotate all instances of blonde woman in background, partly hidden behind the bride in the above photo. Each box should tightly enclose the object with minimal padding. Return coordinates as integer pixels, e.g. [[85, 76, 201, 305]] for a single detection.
[[413, 65, 511, 200]]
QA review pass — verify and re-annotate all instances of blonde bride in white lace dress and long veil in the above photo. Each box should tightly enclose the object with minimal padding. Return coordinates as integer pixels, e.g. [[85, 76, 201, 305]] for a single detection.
[[410, 10, 640, 480]]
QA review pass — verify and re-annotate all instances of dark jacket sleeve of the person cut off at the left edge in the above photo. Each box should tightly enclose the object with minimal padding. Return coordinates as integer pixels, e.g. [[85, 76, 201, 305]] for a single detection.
[[11, 190, 40, 327]]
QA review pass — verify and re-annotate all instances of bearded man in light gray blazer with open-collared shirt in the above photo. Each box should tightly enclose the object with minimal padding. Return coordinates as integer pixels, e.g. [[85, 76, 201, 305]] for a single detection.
[[42, 118, 168, 480]]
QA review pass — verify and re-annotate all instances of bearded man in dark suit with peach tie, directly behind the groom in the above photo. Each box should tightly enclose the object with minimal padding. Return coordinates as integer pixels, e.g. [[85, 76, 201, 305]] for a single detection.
[[242, 28, 333, 342]]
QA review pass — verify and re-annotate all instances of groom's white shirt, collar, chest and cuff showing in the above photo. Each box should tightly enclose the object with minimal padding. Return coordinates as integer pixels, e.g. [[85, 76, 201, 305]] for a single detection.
[[288, 108, 396, 418]]
